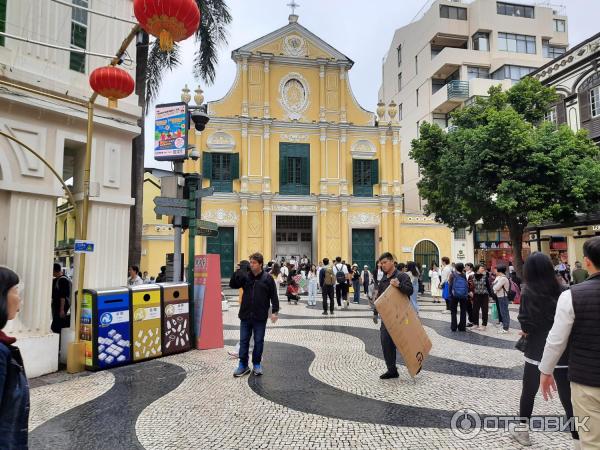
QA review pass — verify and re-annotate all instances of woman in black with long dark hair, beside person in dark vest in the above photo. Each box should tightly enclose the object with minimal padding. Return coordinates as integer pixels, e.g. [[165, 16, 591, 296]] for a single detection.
[[509, 252, 579, 448]]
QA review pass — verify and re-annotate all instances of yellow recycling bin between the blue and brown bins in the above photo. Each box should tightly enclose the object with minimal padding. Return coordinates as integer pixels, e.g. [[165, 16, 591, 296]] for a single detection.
[[129, 284, 161, 361]]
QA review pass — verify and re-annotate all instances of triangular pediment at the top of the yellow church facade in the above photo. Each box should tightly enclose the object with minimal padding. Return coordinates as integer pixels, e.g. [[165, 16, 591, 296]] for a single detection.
[[232, 18, 353, 66]]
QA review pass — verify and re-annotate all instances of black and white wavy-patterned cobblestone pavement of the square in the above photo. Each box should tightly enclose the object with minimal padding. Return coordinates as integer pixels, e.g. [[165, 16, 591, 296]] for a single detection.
[[30, 297, 572, 450]]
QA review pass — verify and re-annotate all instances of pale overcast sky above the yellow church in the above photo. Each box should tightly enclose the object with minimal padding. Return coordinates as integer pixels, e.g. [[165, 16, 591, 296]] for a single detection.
[[145, 0, 600, 168]]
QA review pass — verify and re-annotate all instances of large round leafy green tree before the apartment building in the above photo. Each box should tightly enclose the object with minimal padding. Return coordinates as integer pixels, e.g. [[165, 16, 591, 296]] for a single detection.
[[410, 78, 600, 275]]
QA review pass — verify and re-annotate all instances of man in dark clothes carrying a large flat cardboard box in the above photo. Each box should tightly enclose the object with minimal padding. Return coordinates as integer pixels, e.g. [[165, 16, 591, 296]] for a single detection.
[[375, 252, 413, 380]]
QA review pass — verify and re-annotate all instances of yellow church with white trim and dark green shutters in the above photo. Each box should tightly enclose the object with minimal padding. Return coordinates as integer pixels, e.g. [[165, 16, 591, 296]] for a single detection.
[[166, 14, 451, 277]]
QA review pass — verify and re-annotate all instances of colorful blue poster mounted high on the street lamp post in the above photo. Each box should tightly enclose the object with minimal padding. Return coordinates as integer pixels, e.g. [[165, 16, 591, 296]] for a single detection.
[[154, 102, 188, 161]]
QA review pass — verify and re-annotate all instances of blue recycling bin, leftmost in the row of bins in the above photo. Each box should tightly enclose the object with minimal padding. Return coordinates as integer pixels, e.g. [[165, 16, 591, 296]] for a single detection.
[[79, 288, 131, 370]]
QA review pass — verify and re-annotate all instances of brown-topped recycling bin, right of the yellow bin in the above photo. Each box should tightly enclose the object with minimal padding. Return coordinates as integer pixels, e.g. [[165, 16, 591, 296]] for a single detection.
[[160, 283, 191, 355]]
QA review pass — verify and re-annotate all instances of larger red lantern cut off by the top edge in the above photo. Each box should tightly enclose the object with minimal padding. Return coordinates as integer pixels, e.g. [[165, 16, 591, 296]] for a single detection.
[[133, 0, 200, 51]]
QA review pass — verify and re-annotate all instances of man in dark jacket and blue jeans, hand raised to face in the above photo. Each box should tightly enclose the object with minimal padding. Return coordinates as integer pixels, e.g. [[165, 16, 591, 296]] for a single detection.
[[229, 253, 279, 377]]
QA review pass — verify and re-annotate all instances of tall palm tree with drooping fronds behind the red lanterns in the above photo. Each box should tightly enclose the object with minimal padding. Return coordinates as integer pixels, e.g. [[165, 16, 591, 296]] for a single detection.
[[129, 0, 231, 265]]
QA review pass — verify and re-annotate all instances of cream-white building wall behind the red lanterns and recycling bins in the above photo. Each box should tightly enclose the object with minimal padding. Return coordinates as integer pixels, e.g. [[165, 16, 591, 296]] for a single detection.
[[0, 0, 141, 377]]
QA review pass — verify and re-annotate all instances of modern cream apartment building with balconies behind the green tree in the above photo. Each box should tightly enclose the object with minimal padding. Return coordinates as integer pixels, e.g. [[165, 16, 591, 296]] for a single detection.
[[379, 0, 568, 262]]
